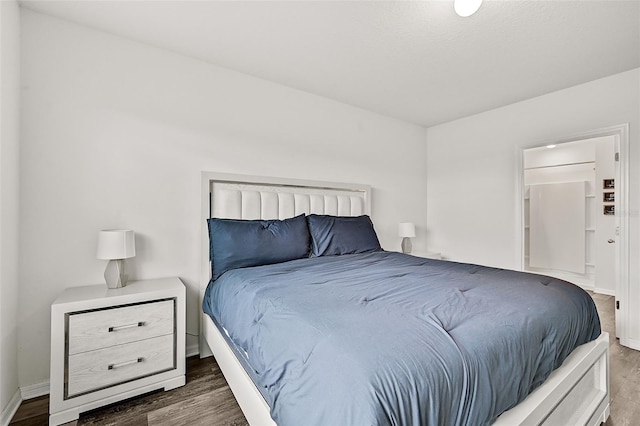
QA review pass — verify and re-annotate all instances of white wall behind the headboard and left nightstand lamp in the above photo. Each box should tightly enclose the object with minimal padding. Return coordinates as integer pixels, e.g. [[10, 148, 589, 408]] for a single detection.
[[19, 11, 427, 386]]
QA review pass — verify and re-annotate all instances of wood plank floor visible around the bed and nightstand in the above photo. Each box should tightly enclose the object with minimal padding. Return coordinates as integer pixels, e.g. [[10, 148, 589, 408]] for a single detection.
[[10, 293, 640, 426]]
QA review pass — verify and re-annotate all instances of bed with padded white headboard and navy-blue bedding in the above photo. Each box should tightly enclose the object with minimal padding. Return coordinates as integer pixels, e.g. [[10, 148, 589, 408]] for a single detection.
[[201, 173, 609, 425]]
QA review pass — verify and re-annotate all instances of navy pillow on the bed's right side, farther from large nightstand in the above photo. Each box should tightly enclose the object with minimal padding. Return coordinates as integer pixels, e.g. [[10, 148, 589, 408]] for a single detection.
[[307, 214, 382, 257]]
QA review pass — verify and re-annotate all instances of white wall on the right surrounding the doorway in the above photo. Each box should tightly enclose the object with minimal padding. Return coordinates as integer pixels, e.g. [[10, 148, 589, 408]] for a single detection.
[[427, 69, 640, 339]]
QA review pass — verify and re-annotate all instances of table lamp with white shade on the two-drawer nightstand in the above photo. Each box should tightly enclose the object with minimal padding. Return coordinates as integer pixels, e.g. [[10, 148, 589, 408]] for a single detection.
[[96, 229, 136, 288]]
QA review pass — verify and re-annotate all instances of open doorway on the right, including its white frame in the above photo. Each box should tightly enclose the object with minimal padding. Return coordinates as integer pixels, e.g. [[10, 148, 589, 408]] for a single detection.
[[519, 125, 636, 347]]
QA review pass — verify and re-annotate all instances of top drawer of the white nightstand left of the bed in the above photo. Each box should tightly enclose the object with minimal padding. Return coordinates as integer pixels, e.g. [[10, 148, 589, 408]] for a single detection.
[[68, 300, 174, 355]]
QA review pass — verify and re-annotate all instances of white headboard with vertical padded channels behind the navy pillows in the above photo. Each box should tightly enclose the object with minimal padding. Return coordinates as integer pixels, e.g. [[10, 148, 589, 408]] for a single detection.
[[198, 172, 371, 356]]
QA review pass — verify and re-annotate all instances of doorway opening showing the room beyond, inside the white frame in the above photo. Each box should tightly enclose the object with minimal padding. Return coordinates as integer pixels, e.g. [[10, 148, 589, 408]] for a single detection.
[[523, 136, 617, 296]]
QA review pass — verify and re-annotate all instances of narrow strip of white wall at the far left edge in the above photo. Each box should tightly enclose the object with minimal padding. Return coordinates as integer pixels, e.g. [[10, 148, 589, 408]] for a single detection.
[[0, 1, 20, 422]]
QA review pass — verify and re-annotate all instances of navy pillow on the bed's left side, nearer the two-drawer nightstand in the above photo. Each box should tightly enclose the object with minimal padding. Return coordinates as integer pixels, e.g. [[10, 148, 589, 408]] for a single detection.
[[207, 215, 310, 280]]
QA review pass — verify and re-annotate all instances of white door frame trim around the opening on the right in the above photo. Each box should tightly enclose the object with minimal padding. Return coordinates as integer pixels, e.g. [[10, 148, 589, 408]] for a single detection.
[[515, 123, 640, 349]]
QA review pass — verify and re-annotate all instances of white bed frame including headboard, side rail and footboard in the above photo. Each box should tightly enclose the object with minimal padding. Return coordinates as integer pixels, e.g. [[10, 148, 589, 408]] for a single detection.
[[199, 172, 609, 426]]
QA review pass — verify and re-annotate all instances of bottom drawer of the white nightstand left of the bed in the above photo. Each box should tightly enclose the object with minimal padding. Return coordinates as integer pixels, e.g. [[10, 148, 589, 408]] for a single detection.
[[65, 334, 176, 399]]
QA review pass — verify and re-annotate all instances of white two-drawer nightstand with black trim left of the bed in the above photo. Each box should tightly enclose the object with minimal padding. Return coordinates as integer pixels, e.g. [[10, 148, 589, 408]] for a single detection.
[[49, 278, 185, 425]]
